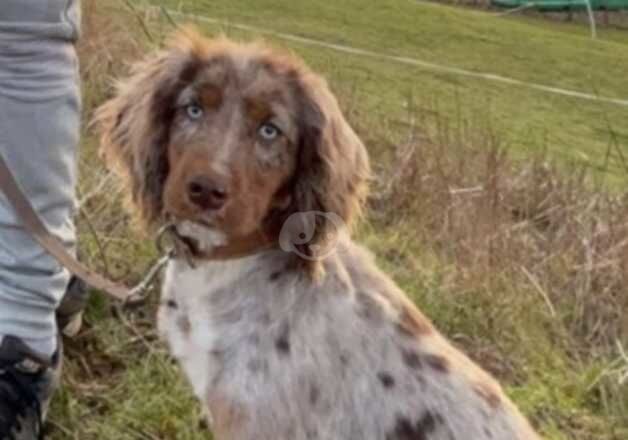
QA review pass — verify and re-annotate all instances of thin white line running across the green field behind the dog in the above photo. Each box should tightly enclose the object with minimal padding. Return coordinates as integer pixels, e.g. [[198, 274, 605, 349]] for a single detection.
[[166, 9, 628, 107]]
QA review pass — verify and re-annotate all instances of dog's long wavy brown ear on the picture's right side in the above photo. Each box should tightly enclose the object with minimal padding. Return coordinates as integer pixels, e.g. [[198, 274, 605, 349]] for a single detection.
[[291, 73, 370, 268]]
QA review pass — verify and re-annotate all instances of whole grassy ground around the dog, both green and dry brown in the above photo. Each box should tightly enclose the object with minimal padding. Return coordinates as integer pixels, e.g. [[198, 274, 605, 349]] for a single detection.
[[50, 0, 628, 440]]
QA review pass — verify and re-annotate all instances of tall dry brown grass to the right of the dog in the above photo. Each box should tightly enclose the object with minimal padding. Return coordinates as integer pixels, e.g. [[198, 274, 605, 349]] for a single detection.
[[372, 111, 628, 355]]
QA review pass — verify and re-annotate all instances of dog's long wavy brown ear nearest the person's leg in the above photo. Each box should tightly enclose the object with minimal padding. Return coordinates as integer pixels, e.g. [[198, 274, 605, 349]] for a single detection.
[[94, 29, 204, 226]]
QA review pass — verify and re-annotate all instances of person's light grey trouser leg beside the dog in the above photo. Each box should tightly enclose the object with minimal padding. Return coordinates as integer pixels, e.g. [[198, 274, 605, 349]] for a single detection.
[[0, 0, 80, 355]]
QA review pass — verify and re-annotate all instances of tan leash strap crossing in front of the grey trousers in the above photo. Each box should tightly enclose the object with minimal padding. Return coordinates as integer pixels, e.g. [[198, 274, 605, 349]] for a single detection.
[[0, 154, 132, 302]]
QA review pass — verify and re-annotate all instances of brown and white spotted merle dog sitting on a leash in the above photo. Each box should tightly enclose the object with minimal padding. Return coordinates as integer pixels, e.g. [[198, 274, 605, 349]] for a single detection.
[[96, 29, 539, 440]]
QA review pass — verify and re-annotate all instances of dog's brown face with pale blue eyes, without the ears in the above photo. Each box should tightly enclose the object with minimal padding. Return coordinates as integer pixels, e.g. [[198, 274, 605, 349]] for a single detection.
[[163, 55, 299, 243]]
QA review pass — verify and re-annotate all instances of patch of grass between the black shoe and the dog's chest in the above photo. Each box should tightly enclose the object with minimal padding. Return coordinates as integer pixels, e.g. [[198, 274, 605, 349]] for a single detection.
[[51, 312, 208, 440]]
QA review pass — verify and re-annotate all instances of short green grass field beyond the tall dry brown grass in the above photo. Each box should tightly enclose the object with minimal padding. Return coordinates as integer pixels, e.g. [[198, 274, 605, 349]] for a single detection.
[[153, 0, 628, 180]]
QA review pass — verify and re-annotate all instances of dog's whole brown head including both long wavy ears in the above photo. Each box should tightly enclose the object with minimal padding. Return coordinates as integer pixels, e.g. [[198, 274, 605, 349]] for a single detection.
[[96, 30, 369, 272]]
